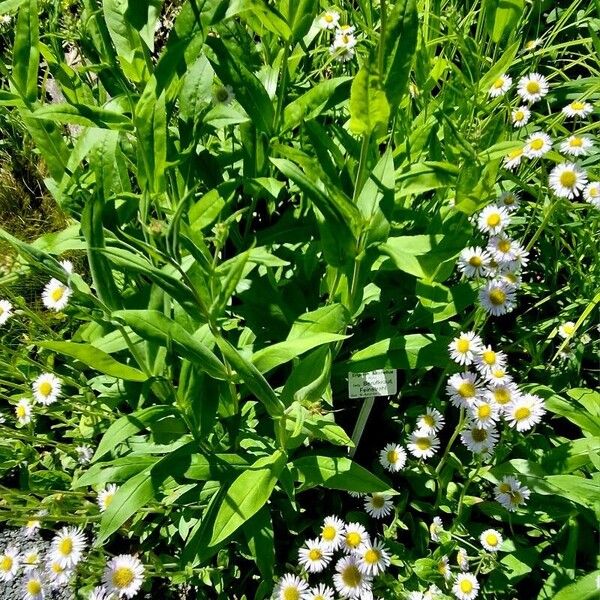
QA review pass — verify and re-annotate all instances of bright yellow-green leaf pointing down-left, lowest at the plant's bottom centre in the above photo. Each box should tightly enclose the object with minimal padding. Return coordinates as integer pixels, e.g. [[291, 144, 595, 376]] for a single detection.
[[208, 450, 286, 546]]
